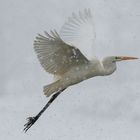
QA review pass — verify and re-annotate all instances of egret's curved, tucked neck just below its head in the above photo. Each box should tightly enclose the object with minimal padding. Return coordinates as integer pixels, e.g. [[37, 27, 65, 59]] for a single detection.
[[102, 60, 117, 75]]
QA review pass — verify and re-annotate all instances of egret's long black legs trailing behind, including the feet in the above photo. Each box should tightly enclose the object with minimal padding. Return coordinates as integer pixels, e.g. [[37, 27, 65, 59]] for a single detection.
[[23, 89, 65, 132]]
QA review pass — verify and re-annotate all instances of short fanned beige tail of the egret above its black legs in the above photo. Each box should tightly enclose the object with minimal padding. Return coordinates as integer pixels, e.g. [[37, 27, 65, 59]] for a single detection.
[[43, 80, 62, 97]]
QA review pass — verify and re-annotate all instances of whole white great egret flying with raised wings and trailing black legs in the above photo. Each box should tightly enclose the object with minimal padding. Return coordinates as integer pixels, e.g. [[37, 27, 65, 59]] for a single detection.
[[24, 9, 137, 132]]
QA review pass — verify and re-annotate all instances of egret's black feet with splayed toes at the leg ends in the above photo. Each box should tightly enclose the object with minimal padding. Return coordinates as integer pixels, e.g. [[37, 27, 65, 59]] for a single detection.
[[23, 117, 37, 132]]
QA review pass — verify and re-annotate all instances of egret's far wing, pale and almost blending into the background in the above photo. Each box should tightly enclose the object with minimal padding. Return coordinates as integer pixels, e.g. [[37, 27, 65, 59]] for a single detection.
[[60, 9, 96, 59]]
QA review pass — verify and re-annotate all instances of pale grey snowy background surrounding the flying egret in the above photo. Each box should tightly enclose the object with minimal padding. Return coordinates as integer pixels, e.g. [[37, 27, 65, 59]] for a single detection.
[[0, 0, 140, 140]]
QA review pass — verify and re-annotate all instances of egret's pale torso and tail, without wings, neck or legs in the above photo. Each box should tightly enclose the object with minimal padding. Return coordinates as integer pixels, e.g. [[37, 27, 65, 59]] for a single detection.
[[44, 59, 106, 96]]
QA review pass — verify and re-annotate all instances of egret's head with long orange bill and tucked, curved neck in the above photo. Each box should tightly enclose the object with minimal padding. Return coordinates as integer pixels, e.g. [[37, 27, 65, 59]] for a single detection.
[[102, 56, 138, 75]]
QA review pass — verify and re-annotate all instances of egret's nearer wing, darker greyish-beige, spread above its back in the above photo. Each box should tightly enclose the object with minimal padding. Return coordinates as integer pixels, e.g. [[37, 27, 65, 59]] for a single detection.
[[34, 31, 89, 75]]
